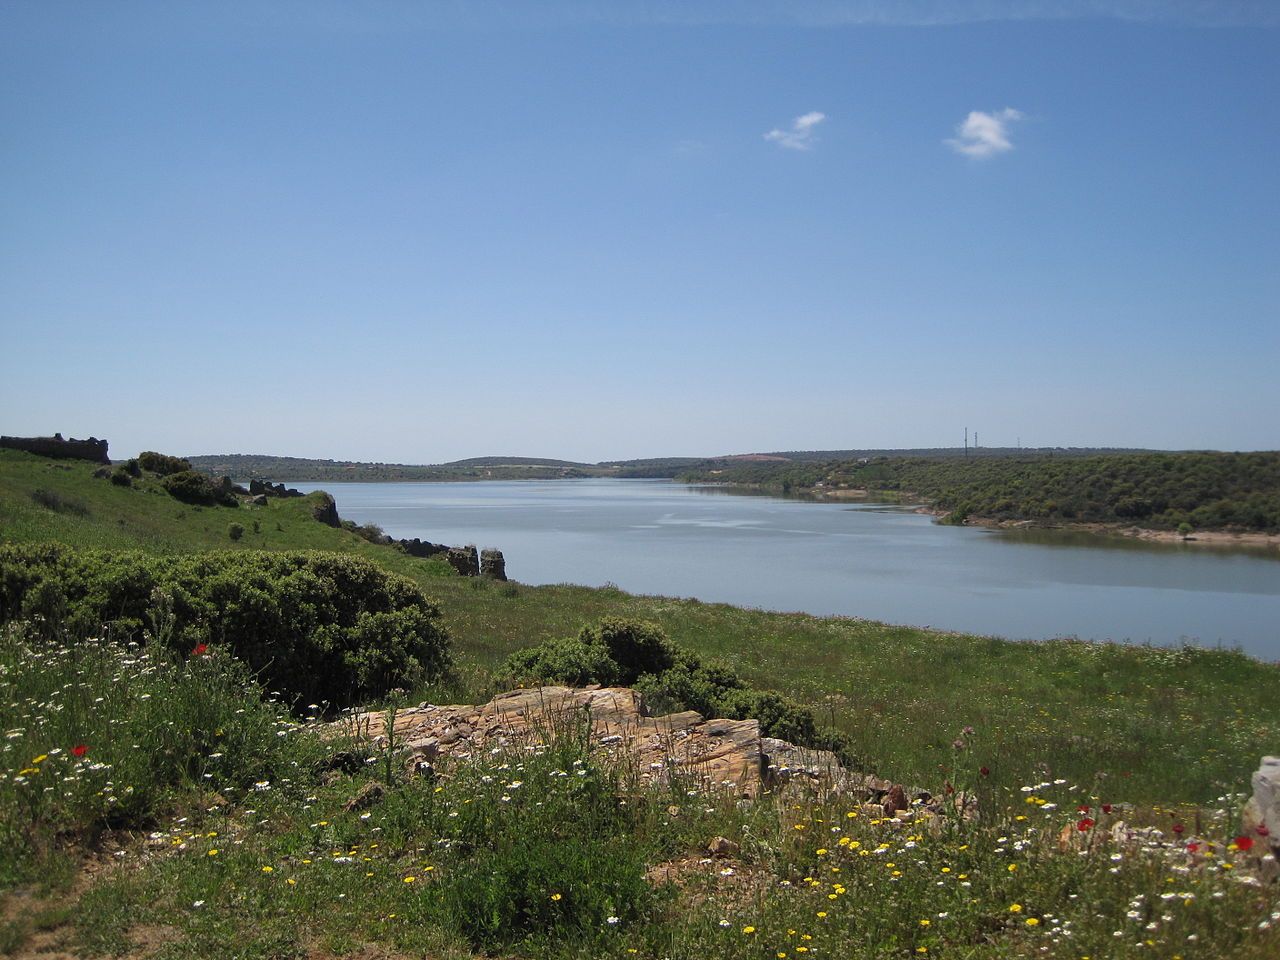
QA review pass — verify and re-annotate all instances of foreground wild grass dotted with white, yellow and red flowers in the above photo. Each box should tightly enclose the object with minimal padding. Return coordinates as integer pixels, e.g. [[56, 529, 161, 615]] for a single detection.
[[0, 627, 1280, 960]]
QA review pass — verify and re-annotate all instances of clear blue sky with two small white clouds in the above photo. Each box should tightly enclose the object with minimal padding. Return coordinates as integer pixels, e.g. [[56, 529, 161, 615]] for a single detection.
[[0, 0, 1280, 462]]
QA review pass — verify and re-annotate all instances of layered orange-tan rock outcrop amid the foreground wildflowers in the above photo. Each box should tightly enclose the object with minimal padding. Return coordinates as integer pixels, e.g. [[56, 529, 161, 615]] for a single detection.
[[329, 686, 932, 815]]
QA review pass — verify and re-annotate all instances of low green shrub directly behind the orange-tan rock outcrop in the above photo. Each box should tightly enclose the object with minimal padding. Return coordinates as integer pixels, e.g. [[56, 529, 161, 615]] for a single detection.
[[503, 618, 851, 759]]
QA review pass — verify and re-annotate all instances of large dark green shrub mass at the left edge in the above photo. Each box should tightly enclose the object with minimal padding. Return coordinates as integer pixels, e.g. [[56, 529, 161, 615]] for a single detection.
[[0, 544, 451, 705]]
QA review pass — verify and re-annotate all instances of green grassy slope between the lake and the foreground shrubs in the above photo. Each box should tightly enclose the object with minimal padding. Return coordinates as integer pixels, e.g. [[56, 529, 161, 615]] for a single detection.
[[0, 451, 1280, 801]]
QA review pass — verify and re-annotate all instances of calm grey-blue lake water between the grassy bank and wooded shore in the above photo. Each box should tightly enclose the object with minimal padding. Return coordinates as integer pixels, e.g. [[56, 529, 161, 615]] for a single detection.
[[296, 480, 1280, 660]]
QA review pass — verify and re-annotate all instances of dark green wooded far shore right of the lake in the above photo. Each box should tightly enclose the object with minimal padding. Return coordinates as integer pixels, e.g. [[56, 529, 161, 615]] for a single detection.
[[680, 452, 1280, 532]]
